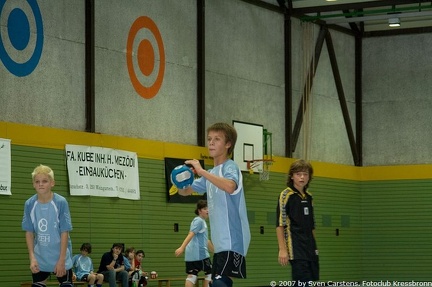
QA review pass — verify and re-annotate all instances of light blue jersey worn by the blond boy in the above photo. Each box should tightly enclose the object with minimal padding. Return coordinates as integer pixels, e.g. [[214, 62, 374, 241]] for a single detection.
[[21, 193, 72, 272]]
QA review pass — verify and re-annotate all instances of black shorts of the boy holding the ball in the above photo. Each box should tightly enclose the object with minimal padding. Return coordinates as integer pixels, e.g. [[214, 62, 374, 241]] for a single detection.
[[212, 251, 246, 278]]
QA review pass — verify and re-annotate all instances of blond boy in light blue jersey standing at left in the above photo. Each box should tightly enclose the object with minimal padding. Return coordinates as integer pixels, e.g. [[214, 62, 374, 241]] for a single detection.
[[21, 165, 73, 287]]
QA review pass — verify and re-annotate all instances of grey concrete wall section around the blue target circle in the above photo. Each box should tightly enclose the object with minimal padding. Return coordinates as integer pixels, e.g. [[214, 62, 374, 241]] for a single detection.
[[0, 0, 85, 130]]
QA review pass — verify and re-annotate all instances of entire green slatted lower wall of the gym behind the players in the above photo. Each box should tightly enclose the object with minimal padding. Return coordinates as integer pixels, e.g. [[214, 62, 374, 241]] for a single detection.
[[0, 145, 432, 287]]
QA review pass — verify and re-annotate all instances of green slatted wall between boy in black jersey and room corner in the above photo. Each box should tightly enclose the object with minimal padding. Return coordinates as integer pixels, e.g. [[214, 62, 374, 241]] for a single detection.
[[309, 177, 361, 281]]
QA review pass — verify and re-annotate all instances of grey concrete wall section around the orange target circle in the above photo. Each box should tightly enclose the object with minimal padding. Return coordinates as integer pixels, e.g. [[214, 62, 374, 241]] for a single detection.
[[95, 0, 197, 144]]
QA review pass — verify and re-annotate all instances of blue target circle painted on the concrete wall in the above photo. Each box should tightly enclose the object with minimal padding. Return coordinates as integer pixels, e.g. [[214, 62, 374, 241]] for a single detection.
[[0, 0, 44, 77]]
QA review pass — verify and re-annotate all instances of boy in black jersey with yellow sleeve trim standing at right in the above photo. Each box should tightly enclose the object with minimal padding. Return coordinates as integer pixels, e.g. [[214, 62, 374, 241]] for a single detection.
[[276, 160, 319, 286]]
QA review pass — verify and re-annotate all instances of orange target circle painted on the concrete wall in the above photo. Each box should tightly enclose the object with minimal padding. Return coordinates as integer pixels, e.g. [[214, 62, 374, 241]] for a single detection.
[[126, 16, 165, 99]]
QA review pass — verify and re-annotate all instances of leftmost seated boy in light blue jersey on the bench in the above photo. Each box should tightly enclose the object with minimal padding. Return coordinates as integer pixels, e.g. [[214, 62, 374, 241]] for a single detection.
[[72, 243, 103, 287]]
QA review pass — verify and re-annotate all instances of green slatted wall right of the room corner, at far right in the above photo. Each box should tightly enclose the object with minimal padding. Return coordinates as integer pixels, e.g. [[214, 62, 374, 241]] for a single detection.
[[361, 180, 432, 281]]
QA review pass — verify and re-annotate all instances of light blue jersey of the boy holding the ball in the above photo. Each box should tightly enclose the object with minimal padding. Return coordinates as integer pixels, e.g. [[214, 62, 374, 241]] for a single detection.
[[192, 159, 250, 256]]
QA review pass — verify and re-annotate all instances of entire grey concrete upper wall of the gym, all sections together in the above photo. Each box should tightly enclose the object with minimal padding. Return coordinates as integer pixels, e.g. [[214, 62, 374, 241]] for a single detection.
[[0, 0, 432, 165]]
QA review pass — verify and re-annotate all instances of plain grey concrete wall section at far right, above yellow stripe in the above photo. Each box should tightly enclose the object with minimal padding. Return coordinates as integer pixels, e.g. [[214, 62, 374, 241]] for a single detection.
[[363, 34, 432, 165]]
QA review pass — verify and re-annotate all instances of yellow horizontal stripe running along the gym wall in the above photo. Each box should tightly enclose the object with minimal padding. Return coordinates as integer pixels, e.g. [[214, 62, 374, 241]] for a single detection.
[[0, 122, 432, 181]]
